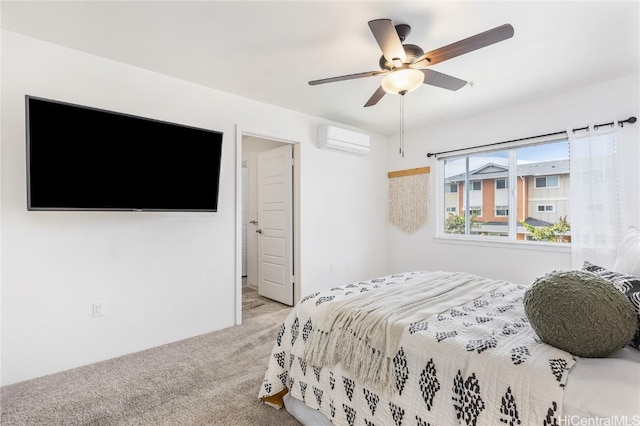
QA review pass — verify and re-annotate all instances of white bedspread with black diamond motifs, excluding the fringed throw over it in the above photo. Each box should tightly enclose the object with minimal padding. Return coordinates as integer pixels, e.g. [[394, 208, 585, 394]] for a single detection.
[[259, 272, 575, 426]]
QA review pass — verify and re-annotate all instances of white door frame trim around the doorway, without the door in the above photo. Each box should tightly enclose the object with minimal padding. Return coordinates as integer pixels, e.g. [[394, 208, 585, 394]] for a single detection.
[[235, 125, 301, 325]]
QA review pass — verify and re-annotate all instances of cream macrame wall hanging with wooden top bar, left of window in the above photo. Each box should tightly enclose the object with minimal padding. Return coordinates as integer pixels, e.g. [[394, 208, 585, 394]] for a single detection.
[[388, 167, 429, 234]]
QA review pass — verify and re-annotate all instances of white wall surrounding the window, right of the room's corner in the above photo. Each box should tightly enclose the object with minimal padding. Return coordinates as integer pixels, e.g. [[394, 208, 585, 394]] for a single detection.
[[387, 75, 640, 283]]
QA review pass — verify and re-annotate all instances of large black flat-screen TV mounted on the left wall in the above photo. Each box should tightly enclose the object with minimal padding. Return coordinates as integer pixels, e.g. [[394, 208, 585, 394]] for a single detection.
[[26, 96, 222, 212]]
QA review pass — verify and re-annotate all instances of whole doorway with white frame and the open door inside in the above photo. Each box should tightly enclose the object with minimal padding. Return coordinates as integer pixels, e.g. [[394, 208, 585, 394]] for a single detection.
[[236, 128, 300, 324]]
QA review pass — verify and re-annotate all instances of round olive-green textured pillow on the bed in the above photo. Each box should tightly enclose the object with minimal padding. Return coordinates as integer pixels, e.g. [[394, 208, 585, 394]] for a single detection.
[[524, 271, 638, 358]]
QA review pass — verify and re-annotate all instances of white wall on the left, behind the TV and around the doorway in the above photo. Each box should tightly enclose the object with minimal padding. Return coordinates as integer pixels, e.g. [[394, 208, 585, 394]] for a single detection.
[[0, 32, 387, 385]]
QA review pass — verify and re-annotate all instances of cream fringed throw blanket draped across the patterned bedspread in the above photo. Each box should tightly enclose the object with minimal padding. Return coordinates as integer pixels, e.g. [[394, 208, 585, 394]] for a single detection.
[[304, 272, 506, 391]]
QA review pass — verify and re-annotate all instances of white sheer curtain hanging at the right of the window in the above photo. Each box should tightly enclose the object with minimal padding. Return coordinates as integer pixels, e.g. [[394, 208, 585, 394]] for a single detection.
[[569, 131, 626, 269]]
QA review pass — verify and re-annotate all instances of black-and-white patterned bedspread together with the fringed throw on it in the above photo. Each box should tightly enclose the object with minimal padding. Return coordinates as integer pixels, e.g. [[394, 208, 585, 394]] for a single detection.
[[259, 272, 575, 426]]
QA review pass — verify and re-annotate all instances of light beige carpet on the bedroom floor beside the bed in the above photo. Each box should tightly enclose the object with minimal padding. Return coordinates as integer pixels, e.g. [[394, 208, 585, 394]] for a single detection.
[[0, 309, 299, 426]]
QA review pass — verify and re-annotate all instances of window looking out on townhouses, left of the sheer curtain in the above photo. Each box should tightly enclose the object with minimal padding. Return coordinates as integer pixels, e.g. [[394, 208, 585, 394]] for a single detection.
[[438, 140, 571, 242]]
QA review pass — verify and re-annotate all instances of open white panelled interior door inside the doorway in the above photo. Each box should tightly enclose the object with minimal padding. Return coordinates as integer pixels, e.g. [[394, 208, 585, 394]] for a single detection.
[[256, 144, 294, 306]]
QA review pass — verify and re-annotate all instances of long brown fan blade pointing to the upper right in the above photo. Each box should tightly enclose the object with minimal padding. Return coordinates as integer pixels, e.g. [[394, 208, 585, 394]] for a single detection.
[[413, 24, 513, 66]]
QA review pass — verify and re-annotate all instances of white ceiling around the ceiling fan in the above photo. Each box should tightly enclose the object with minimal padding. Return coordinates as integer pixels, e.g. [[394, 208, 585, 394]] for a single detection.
[[1, 0, 640, 134]]
